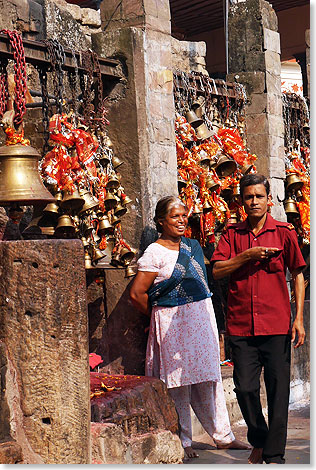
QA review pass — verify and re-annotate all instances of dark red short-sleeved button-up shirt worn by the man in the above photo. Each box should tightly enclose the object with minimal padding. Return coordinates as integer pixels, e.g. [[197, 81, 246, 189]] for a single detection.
[[211, 214, 306, 336]]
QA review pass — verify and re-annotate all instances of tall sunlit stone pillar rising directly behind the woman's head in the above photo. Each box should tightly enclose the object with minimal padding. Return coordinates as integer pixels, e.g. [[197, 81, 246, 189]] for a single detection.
[[92, 0, 177, 247]]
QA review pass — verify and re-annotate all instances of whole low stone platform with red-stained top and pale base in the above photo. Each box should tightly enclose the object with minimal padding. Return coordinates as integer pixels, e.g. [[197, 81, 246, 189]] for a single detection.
[[90, 372, 183, 464]]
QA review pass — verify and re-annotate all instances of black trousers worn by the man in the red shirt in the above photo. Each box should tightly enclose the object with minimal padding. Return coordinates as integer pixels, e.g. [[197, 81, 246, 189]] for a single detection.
[[229, 335, 291, 463]]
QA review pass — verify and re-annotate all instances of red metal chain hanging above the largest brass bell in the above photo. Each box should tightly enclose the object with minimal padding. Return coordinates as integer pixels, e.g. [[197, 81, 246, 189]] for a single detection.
[[0, 29, 27, 128]]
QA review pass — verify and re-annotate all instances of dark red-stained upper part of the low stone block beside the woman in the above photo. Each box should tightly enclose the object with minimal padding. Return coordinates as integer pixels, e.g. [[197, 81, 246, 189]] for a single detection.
[[90, 372, 178, 436]]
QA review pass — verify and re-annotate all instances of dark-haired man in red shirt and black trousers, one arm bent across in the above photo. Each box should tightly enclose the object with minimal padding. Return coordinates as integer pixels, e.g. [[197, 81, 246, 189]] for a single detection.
[[211, 174, 305, 464]]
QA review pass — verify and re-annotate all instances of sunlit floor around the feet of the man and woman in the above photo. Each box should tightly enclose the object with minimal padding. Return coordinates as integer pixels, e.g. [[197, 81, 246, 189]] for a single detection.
[[184, 403, 310, 465]]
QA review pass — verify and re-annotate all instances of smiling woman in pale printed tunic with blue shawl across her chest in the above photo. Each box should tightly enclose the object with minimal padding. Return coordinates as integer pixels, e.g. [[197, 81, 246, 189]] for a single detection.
[[130, 196, 250, 458]]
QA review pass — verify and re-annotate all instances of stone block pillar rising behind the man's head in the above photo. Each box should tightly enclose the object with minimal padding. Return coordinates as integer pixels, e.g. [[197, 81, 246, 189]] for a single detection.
[[227, 0, 286, 220]]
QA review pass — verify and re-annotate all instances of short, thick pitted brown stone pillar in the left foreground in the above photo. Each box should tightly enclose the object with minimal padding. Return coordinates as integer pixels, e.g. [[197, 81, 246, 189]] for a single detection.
[[0, 240, 90, 464]]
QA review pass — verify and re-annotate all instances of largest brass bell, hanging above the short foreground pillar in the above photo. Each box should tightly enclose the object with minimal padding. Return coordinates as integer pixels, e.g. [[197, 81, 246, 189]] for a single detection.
[[0, 144, 55, 206]]
